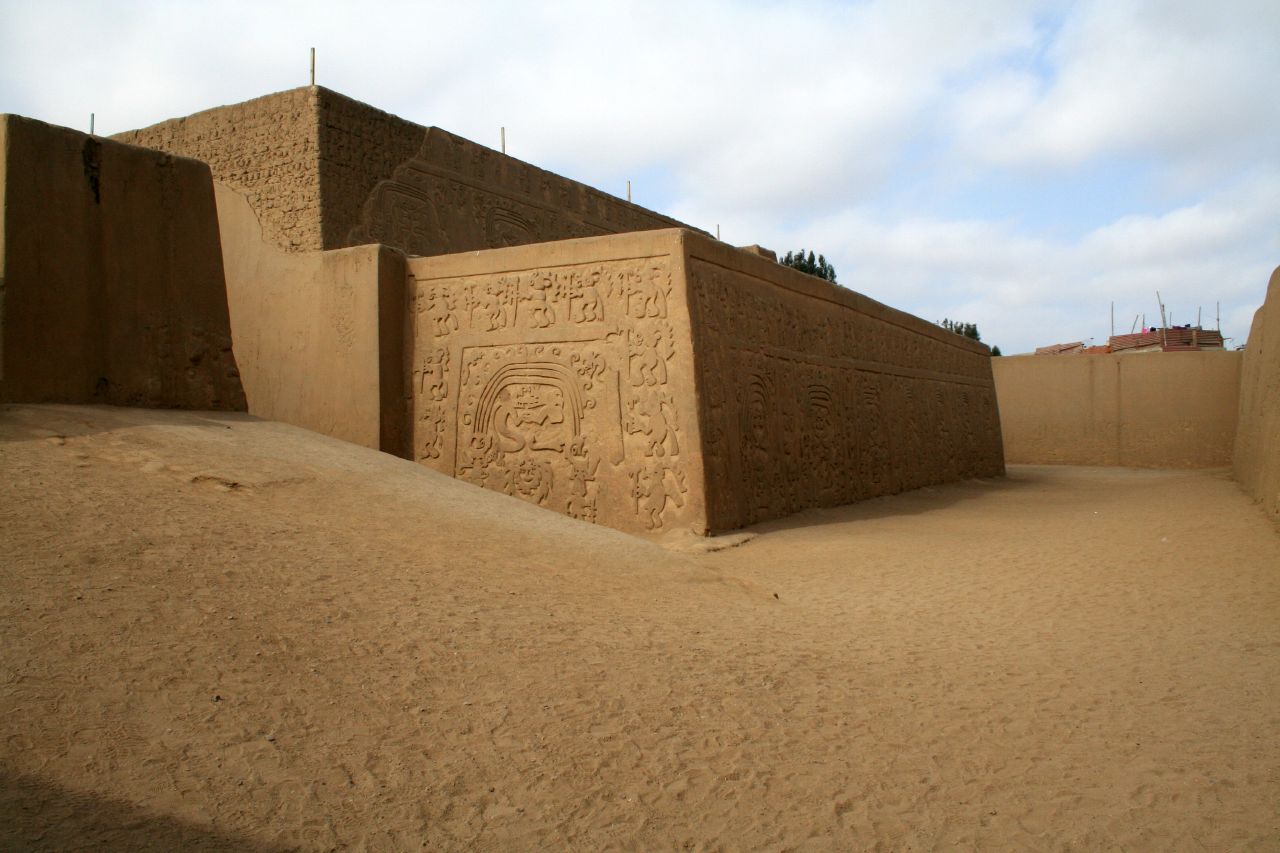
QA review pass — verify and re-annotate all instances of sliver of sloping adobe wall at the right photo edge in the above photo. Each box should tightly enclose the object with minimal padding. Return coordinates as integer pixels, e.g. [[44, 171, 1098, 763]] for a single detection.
[[1233, 269, 1280, 525]]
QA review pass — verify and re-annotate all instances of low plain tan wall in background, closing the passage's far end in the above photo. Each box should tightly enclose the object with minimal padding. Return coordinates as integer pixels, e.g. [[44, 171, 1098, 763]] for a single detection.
[[992, 351, 1240, 467]]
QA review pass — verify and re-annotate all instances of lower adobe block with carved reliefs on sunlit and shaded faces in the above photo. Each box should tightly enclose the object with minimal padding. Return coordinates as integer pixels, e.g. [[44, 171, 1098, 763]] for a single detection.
[[407, 229, 1004, 533]]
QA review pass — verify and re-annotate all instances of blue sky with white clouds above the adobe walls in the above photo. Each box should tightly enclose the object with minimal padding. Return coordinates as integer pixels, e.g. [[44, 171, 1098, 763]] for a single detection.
[[0, 0, 1280, 353]]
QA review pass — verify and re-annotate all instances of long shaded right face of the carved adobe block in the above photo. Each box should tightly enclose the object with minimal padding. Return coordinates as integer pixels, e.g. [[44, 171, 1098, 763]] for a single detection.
[[686, 234, 1005, 530]]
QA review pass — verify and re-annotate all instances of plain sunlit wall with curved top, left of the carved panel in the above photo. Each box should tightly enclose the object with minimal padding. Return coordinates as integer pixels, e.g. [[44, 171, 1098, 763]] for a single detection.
[[216, 184, 407, 456]]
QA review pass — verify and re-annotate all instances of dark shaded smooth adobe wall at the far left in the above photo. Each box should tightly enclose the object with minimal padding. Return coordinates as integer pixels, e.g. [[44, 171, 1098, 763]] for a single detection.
[[0, 115, 244, 410]]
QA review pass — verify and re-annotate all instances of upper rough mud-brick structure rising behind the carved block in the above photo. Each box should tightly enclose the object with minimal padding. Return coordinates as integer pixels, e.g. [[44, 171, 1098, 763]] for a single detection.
[[115, 86, 682, 255]]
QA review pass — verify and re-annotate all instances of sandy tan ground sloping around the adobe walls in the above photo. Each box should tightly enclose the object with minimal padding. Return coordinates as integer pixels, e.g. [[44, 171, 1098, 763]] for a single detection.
[[0, 406, 1280, 850]]
